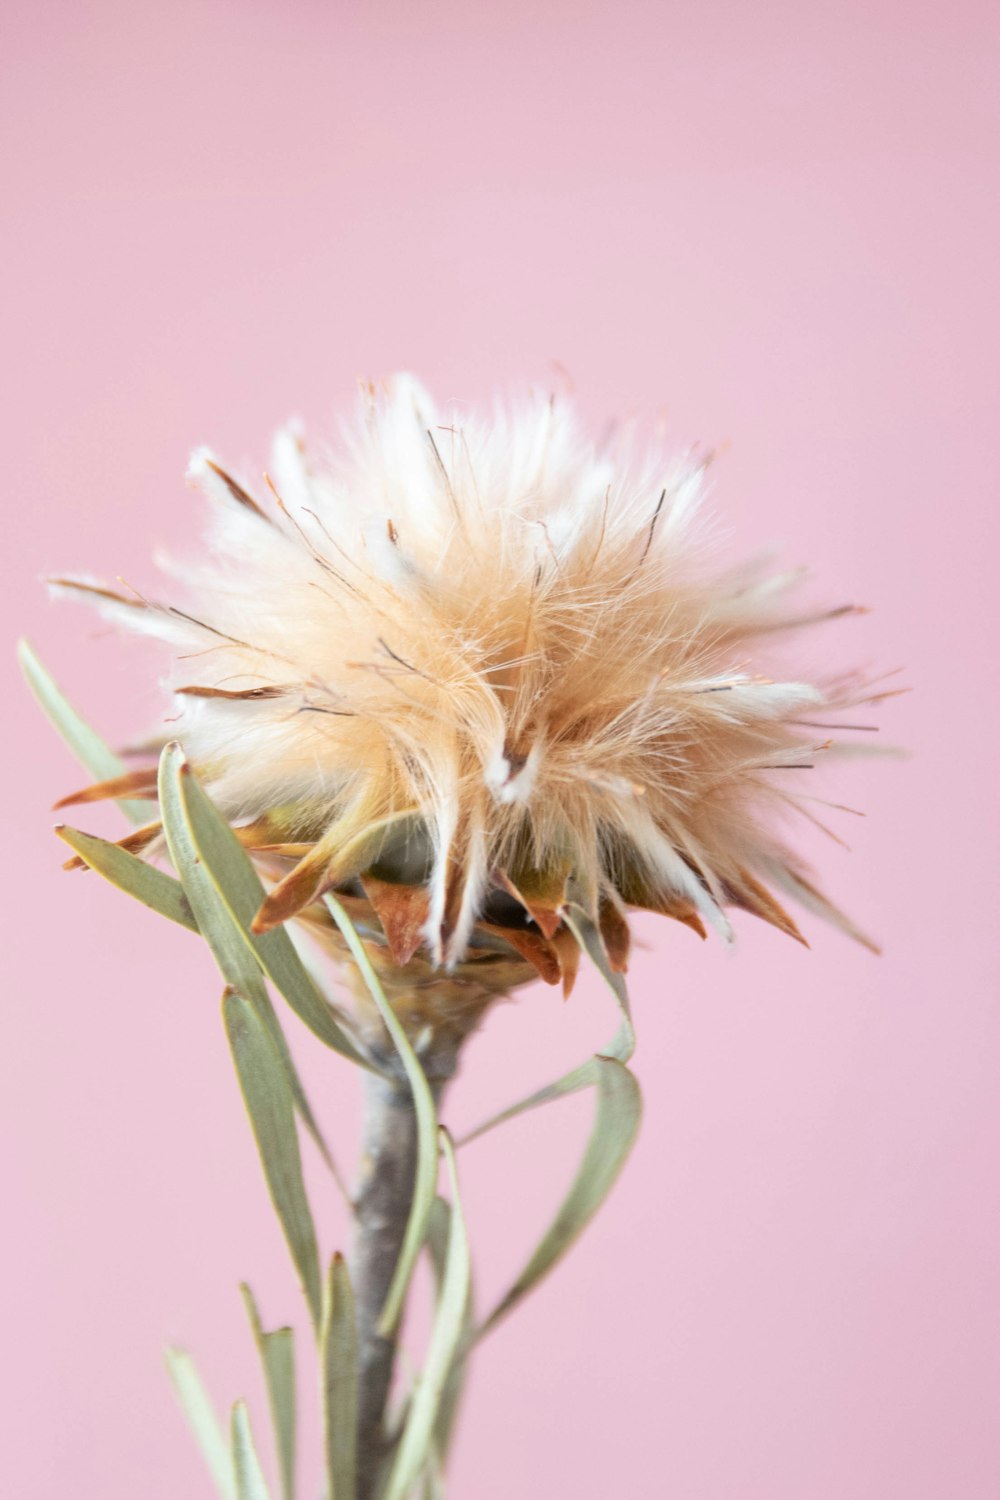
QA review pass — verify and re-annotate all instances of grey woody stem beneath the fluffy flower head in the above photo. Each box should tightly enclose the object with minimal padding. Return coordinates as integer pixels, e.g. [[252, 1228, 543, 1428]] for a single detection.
[[351, 1058, 454, 1500]]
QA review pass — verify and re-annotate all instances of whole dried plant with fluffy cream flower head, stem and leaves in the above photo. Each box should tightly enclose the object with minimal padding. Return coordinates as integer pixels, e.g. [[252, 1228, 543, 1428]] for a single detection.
[[25, 378, 888, 1500]]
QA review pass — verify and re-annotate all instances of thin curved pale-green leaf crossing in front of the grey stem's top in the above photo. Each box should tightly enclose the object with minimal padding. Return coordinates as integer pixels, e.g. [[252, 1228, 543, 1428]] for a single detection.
[[324, 896, 438, 1335]]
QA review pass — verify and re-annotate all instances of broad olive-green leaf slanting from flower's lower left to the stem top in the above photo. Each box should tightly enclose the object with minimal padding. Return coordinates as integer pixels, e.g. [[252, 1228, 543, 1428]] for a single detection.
[[180, 765, 370, 1068]]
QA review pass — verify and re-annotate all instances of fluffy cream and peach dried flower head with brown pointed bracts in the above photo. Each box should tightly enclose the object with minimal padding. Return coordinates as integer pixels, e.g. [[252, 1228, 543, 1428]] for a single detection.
[[57, 378, 885, 1038]]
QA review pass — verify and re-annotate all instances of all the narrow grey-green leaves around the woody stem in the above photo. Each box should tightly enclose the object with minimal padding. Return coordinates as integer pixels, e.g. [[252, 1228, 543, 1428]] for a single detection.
[[29, 642, 650, 1500]]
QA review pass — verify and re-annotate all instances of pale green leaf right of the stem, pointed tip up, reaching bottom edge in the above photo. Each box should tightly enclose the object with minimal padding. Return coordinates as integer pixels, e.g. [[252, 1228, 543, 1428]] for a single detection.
[[384, 1130, 471, 1500]]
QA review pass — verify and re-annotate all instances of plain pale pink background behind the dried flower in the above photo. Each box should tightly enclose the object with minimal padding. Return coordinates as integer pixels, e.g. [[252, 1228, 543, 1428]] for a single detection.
[[0, 0, 1000, 1500]]
